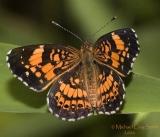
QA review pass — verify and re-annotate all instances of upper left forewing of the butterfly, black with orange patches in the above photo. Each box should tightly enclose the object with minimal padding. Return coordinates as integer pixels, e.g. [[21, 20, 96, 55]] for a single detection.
[[7, 44, 79, 91]]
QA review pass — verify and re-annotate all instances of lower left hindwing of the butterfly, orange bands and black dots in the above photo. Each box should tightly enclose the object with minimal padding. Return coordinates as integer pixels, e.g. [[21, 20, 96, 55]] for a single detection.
[[47, 63, 93, 121]]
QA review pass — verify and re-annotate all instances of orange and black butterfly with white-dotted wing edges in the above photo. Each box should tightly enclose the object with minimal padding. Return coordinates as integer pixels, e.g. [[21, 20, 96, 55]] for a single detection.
[[6, 28, 140, 121]]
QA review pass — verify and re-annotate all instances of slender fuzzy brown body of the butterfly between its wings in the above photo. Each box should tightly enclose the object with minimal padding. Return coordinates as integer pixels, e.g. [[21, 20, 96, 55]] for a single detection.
[[81, 42, 98, 107]]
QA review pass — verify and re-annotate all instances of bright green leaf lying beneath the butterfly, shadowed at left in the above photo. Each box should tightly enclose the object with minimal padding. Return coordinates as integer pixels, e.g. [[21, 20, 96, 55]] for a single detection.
[[0, 43, 160, 113]]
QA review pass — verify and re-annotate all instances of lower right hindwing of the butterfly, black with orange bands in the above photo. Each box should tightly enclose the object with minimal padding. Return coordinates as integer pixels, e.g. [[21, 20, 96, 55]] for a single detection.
[[96, 63, 125, 115]]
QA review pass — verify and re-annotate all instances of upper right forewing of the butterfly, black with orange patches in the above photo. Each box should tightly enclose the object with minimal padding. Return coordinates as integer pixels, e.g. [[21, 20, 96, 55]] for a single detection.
[[95, 28, 139, 77]]
